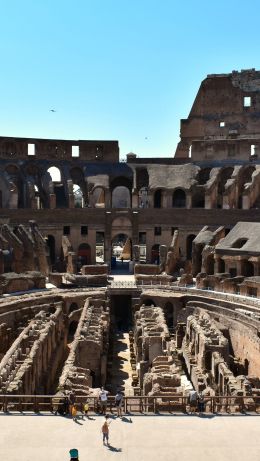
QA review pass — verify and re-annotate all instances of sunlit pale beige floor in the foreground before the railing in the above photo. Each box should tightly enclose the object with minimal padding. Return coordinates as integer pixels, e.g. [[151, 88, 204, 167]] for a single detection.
[[0, 414, 260, 461]]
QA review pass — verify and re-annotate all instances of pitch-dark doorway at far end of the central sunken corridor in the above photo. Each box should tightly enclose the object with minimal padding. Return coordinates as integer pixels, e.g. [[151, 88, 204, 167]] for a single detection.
[[111, 295, 132, 331]]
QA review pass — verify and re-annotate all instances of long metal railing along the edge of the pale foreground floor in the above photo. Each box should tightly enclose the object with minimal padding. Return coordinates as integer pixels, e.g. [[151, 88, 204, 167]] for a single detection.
[[0, 394, 260, 414]]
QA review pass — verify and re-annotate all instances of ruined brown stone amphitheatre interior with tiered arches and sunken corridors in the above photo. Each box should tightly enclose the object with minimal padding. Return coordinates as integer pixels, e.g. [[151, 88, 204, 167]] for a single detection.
[[0, 69, 260, 404]]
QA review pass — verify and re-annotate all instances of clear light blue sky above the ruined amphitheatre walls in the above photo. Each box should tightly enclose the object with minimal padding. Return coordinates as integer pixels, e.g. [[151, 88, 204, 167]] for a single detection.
[[0, 0, 260, 157]]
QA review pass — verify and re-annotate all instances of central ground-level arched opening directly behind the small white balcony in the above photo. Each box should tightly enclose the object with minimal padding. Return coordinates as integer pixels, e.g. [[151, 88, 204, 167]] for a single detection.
[[111, 234, 132, 274]]
